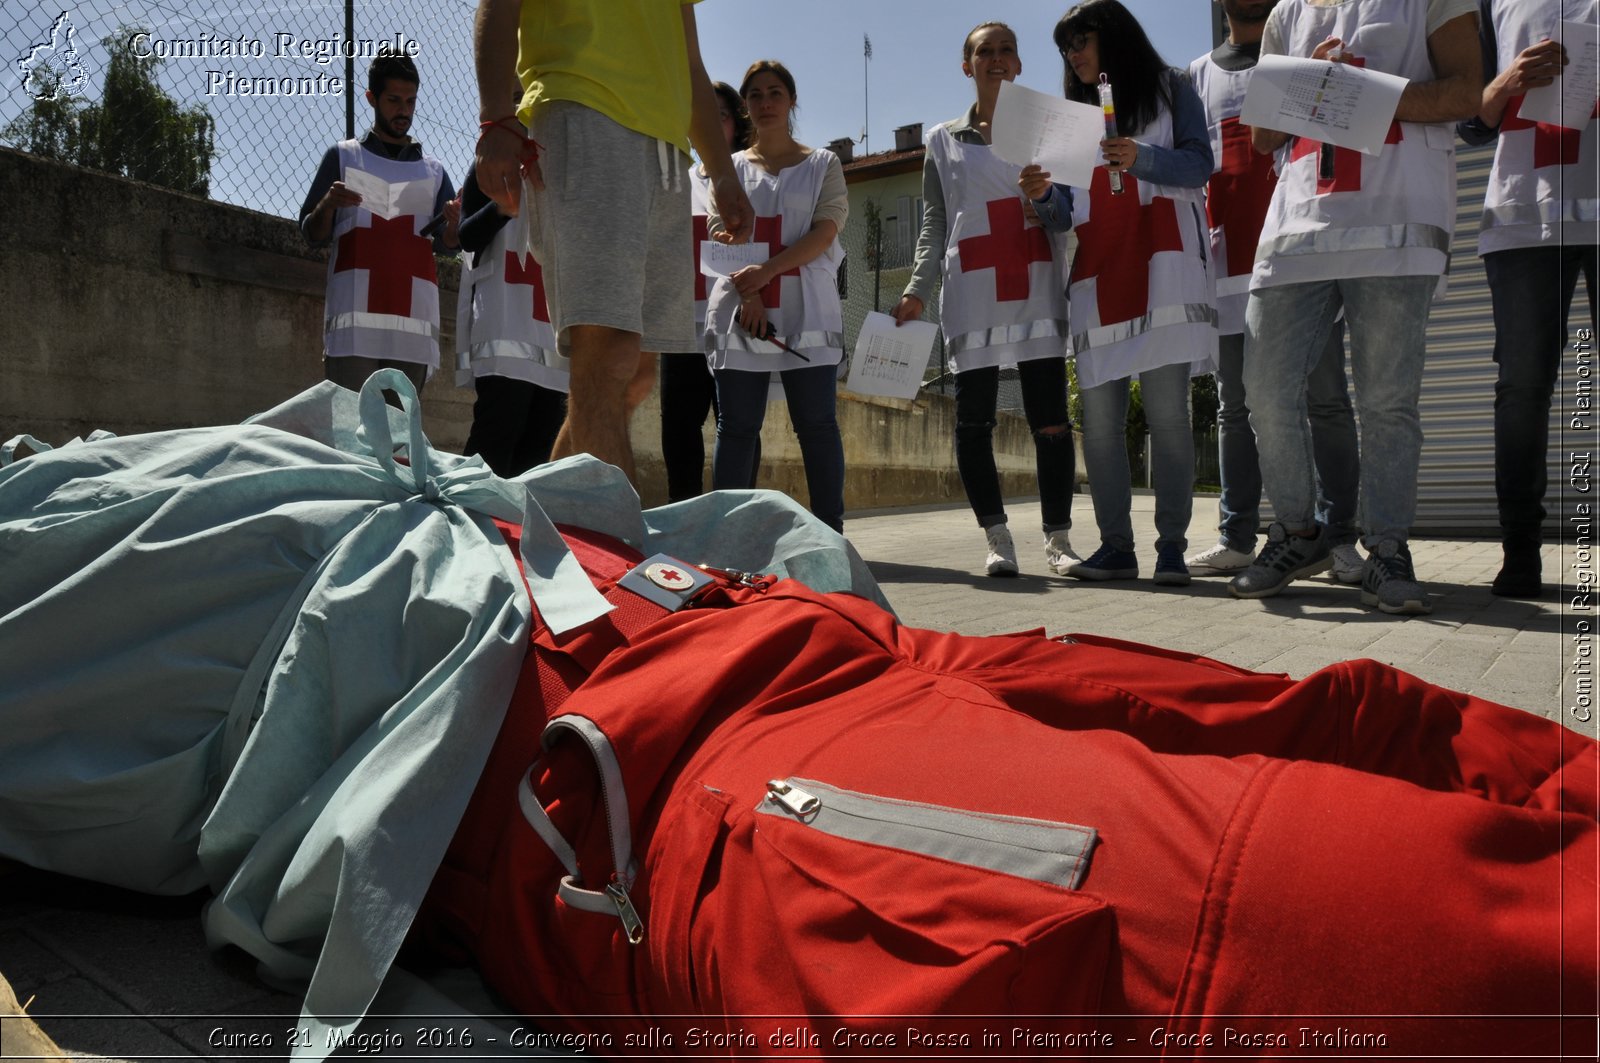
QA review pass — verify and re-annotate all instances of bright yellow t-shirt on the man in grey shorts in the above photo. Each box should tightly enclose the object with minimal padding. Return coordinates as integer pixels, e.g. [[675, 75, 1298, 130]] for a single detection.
[[517, 0, 699, 150]]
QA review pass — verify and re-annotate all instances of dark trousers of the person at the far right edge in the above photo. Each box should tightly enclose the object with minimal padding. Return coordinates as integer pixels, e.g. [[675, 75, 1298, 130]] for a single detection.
[[1483, 245, 1600, 546]]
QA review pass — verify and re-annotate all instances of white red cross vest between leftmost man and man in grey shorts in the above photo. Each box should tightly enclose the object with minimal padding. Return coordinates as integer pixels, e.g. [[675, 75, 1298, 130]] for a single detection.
[[456, 217, 570, 392]]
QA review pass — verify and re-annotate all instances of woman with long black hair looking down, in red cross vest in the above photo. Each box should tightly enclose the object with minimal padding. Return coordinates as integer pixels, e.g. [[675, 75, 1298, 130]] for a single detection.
[[1021, 0, 1218, 586]]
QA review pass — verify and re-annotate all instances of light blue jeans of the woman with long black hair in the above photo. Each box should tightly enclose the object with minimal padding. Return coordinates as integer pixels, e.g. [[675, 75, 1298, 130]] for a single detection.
[[1083, 362, 1195, 551]]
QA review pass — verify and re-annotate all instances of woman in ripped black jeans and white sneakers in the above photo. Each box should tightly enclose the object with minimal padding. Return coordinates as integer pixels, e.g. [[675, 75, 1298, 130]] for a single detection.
[[894, 22, 1078, 576]]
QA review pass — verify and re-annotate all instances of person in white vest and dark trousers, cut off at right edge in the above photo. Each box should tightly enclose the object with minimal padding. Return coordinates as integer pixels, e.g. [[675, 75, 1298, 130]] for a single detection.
[[1458, 0, 1600, 597]]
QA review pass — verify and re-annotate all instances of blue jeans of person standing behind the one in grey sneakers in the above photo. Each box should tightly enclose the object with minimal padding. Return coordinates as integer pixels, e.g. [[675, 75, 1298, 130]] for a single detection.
[[1216, 320, 1362, 554]]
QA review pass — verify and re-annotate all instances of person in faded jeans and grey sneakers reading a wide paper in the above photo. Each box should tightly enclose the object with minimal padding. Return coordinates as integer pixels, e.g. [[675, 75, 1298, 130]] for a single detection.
[[1229, 0, 1483, 615]]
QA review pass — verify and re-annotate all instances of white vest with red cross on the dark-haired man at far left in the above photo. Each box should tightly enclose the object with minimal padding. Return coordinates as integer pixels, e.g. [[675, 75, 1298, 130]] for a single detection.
[[323, 141, 445, 368]]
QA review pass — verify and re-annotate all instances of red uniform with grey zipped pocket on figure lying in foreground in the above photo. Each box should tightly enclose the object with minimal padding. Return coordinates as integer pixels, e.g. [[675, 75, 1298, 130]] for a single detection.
[[418, 530, 1600, 1058]]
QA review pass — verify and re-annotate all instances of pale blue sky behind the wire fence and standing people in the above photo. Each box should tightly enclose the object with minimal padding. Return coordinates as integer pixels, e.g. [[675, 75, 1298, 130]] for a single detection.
[[0, 0, 1213, 216]]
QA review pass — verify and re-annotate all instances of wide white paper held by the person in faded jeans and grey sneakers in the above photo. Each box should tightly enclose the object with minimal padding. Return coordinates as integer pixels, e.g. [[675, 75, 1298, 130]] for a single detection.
[[1238, 56, 1410, 155]]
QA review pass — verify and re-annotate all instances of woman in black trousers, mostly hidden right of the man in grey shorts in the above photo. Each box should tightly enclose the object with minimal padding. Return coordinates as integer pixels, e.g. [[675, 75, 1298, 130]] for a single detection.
[[661, 82, 760, 503]]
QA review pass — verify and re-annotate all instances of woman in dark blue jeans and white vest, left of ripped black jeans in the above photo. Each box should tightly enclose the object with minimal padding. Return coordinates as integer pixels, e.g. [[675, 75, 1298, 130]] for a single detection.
[[706, 59, 850, 532]]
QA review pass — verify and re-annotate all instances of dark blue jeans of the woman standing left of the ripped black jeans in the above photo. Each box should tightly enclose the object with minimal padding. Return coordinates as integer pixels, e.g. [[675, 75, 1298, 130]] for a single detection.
[[710, 365, 845, 532]]
